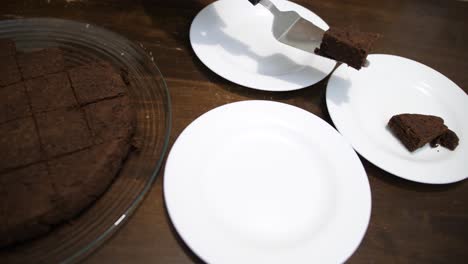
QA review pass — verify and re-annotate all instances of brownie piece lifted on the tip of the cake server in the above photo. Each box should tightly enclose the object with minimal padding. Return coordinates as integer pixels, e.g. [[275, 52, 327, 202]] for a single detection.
[[315, 27, 380, 70]]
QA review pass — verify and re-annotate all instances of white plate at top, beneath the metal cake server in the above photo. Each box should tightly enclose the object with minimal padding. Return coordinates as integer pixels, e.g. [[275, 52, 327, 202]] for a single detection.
[[190, 0, 336, 91]]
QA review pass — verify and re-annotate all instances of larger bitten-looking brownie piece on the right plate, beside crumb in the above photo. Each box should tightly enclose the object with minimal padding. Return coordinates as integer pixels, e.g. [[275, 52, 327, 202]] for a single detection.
[[388, 114, 448, 152]]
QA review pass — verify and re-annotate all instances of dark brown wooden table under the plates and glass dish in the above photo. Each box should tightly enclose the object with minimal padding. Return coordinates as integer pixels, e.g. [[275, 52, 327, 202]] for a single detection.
[[0, 0, 468, 263]]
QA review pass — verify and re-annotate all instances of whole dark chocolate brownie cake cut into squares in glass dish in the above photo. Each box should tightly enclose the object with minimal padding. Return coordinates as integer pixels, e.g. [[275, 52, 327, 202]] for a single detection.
[[0, 41, 136, 247]]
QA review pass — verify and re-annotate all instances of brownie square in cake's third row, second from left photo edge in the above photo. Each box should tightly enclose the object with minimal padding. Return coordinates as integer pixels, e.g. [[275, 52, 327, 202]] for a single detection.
[[36, 108, 92, 158]]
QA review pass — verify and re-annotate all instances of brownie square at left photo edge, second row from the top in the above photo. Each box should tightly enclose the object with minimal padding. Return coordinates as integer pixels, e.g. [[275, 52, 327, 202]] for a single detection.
[[0, 82, 31, 124]]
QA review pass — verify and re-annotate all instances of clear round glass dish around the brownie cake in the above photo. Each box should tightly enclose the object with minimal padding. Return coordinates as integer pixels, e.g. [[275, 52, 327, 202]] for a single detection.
[[0, 18, 171, 263]]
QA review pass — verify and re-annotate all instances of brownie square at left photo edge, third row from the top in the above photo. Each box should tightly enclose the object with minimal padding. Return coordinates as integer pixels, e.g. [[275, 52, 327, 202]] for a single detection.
[[0, 117, 41, 171]]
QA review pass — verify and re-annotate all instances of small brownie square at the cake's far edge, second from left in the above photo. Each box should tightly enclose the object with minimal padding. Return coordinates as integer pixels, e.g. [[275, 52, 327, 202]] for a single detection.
[[17, 48, 65, 79]]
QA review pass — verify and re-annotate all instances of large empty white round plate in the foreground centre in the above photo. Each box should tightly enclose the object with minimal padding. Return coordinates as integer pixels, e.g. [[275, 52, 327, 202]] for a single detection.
[[164, 101, 371, 263]]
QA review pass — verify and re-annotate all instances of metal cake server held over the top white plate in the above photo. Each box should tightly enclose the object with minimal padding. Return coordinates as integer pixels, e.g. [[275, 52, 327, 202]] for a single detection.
[[249, 0, 369, 67]]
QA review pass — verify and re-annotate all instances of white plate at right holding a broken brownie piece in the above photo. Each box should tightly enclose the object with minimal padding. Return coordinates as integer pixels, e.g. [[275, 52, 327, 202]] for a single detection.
[[327, 55, 468, 184]]
